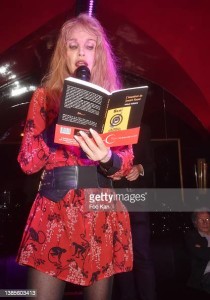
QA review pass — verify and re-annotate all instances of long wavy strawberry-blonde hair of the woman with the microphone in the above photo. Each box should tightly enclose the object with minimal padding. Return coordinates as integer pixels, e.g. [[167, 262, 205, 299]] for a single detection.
[[42, 13, 121, 105]]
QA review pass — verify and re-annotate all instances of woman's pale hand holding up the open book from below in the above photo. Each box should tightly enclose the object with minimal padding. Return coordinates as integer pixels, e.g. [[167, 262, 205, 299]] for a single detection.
[[74, 129, 112, 163]]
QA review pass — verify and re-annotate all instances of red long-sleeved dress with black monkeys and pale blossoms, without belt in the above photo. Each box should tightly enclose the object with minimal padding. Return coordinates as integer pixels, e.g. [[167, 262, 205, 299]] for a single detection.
[[17, 88, 133, 285]]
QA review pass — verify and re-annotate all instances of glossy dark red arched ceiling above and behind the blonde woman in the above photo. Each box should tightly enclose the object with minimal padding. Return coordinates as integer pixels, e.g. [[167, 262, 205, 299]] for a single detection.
[[0, 0, 210, 141]]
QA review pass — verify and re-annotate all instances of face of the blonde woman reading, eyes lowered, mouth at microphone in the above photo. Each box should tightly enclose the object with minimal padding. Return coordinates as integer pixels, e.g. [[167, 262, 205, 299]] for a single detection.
[[66, 27, 97, 75]]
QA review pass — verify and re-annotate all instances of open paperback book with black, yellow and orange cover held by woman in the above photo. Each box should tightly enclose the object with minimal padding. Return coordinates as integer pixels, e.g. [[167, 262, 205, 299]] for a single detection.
[[54, 77, 148, 147]]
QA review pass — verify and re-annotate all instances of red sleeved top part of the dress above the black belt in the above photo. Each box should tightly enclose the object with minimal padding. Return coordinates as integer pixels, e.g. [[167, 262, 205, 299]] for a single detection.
[[18, 88, 133, 176]]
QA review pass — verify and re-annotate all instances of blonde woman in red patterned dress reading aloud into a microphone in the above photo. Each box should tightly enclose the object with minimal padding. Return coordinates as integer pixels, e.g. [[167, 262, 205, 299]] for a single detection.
[[17, 14, 133, 300]]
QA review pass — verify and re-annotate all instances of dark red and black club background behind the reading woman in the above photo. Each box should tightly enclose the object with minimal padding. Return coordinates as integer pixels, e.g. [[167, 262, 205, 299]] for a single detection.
[[0, 0, 210, 300]]
